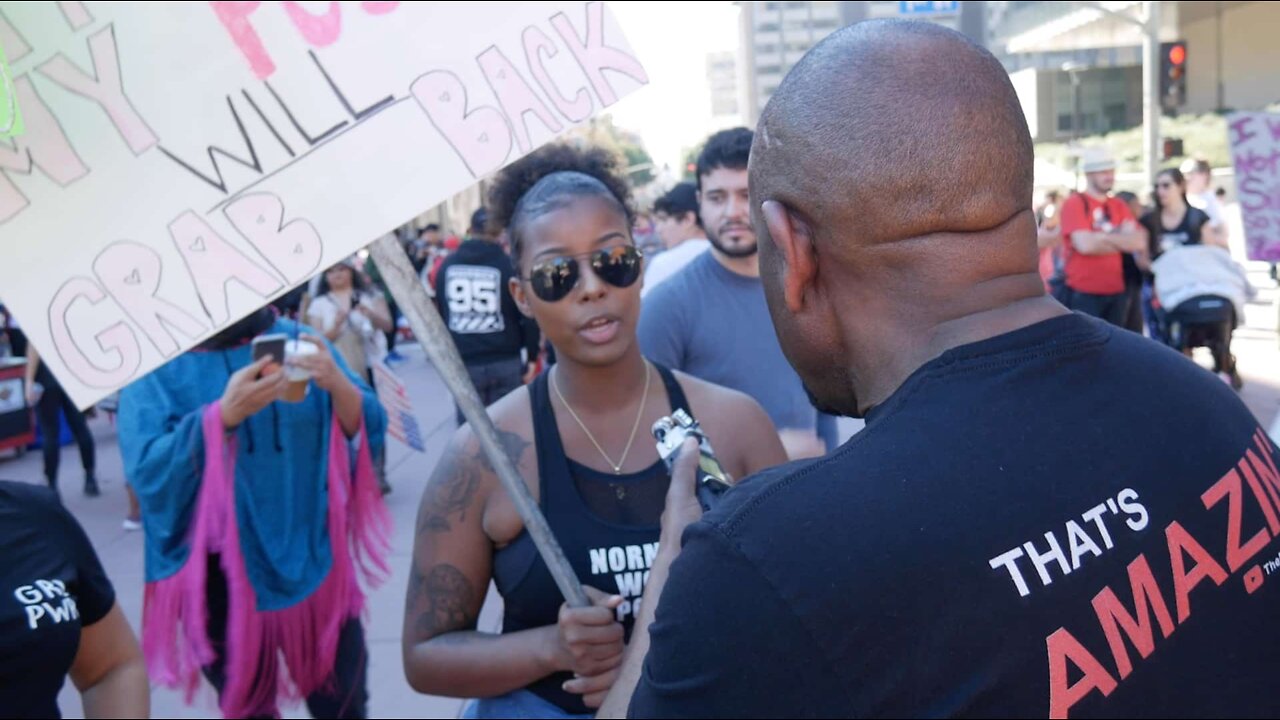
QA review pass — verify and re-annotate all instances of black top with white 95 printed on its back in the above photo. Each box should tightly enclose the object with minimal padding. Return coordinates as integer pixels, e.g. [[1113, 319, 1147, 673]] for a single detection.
[[435, 240, 539, 365]]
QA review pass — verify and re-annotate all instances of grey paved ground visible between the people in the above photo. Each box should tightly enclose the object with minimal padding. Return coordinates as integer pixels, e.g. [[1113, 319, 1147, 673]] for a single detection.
[[0, 243, 1280, 717]]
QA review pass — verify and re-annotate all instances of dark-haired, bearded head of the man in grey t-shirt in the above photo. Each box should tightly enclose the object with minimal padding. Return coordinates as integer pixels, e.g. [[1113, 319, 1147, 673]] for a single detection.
[[698, 128, 756, 258]]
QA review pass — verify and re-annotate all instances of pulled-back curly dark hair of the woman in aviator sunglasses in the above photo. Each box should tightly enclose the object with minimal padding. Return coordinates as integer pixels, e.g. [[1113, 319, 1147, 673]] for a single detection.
[[488, 143, 635, 266]]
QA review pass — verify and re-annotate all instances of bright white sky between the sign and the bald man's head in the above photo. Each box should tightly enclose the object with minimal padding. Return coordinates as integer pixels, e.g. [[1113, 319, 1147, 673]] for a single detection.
[[609, 1, 739, 174]]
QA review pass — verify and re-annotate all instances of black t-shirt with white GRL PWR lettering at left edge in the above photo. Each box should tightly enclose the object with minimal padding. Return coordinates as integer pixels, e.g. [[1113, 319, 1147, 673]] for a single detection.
[[0, 480, 115, 717]]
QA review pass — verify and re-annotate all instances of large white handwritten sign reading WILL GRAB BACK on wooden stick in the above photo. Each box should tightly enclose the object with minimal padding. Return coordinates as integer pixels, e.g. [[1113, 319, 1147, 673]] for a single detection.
[[0, 3, 648, 406]]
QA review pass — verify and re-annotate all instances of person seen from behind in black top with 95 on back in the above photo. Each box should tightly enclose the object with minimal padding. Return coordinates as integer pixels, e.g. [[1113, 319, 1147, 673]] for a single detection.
[[435, 208, 539, 425]]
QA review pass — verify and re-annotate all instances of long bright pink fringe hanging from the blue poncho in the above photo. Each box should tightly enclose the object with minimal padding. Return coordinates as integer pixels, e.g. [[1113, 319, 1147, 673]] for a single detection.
[[142, 402, 390, 717]]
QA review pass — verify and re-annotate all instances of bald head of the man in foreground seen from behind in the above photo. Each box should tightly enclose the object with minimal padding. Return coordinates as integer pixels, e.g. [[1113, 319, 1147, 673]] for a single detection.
[[747, 20, 1044, 415]]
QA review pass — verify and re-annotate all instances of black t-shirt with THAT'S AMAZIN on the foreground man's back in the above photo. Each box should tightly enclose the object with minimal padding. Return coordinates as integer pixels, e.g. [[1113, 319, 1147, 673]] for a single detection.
[[631, 315, 1280, 717]]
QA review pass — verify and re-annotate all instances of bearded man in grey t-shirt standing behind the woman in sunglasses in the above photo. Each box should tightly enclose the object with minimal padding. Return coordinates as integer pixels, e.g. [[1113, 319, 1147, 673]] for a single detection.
[[639, 128, 826, 459]]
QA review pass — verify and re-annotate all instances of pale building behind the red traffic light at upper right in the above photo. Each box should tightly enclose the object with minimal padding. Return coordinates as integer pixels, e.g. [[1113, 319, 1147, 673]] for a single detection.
[[987, 1, 1280, 141]]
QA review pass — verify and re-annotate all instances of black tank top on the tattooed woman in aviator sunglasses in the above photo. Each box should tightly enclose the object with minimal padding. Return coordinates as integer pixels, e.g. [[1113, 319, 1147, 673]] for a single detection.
[[493, 364, 692, 714]]
